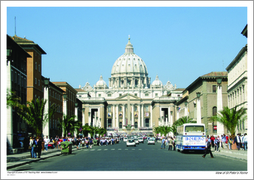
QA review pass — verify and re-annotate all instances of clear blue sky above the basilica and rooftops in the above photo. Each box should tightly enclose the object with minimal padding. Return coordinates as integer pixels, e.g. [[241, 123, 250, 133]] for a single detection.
[[7, 2, 247, 88]]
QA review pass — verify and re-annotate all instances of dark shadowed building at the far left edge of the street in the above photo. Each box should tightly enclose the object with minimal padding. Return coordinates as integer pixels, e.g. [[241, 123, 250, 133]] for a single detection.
[[6, 35, 31, 153]]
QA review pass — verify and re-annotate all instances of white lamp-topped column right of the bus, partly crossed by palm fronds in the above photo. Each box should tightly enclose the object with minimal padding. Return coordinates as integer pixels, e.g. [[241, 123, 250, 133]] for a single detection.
[[217, 79, 224, 136]]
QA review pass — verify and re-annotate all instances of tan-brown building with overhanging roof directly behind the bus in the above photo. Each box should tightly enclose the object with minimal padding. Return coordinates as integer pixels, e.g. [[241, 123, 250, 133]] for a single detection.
[[180, 72, 228, 135]]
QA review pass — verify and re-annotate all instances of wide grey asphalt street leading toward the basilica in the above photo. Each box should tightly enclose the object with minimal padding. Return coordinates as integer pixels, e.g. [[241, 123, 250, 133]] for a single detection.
[[6, 141, 247, 171]]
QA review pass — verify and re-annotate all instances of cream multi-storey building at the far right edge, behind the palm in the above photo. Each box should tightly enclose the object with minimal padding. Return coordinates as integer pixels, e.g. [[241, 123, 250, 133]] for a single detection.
[[226, 25, 248, 134]]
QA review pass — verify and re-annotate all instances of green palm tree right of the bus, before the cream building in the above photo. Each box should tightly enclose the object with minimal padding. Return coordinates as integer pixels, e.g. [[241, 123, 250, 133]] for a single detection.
[[212, 107, 247, 136]]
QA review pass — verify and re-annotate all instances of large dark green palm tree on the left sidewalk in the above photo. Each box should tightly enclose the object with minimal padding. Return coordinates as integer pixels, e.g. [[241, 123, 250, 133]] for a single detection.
[[17, 99, 57, 136]]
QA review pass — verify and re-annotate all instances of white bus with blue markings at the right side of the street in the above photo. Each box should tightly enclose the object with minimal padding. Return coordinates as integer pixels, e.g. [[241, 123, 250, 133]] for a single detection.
[[175, 123, 206, 151]]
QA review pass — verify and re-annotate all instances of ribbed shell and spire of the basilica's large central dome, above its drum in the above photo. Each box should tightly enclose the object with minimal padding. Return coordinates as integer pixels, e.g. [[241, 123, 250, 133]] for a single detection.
[[111, 38, 148, 77]]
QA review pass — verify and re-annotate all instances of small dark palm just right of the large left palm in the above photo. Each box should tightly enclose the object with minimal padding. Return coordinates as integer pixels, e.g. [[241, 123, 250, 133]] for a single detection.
[[59, 115, 80, 137]]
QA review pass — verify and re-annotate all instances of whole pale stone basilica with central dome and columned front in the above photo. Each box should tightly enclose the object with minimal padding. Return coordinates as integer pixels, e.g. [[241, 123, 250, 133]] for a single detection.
[[76, 38, 184, 134]]
